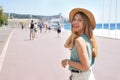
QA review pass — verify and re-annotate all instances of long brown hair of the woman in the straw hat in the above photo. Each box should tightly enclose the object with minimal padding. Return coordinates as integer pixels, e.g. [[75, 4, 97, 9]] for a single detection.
[[71, 12, 98, 58]]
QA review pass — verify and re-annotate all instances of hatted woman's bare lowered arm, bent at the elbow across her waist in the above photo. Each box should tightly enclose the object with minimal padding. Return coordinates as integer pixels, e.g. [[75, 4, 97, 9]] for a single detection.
[[68, 37, 90, 70]]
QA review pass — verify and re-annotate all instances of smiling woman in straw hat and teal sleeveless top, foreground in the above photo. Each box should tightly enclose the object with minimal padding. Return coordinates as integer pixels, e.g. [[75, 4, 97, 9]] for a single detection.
[[61, 8, 97, 80]]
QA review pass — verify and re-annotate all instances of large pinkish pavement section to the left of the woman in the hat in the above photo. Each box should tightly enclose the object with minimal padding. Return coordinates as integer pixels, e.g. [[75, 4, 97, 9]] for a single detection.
[[0, 29, 69, 80]]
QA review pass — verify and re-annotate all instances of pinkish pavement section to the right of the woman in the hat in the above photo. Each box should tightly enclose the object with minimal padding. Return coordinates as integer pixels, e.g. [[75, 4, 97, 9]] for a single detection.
[[94, 37, 120, 80]]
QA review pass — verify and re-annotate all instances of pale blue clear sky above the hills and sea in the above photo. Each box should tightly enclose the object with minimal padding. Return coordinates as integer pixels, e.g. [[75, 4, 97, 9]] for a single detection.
[[0, 0, 120, 23]]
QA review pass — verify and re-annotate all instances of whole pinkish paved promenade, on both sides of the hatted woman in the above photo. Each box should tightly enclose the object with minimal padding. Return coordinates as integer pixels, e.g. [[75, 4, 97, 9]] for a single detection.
[[0, 28, 120, 80]]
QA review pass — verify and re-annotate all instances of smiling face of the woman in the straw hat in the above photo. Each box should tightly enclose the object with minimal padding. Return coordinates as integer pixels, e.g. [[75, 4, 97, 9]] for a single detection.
[[72, 14, 84, 34]]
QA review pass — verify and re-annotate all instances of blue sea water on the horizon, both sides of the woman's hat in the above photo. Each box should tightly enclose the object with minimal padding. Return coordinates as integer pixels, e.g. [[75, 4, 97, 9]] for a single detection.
[[64, 23, 120, 30]]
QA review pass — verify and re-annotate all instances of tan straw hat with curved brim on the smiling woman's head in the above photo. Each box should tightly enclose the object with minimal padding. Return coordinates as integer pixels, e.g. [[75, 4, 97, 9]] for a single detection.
[[69, 8, 96, 29]]
